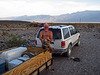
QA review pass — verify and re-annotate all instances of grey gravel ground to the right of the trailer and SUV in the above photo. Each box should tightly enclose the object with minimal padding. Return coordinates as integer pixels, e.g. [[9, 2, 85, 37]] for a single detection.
[[40, 32, 100, 75]]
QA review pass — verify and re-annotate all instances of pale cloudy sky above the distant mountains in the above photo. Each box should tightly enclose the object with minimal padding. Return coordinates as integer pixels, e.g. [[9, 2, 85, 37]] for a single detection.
[[0, 0, 100, 18]]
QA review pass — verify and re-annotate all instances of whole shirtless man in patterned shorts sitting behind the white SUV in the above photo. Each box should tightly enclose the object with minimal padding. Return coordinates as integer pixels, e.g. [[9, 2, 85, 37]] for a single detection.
[[39, 24, 53, 53]]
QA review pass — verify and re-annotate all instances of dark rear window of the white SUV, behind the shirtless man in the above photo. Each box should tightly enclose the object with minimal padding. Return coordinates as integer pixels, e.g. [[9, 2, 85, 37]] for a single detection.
[[37, 29, 62, 39]]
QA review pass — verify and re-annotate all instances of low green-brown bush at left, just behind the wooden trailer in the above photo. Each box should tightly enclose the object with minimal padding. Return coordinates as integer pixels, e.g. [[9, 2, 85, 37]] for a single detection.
[[0, 34, 27, 48]]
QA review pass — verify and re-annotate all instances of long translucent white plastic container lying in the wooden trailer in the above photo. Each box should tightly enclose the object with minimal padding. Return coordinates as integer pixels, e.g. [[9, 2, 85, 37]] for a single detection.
[[1, 47, 27, 62]]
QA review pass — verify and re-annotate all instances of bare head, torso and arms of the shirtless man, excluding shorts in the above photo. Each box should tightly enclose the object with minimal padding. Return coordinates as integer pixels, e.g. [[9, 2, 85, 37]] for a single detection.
[[39, 24, 53, 44]]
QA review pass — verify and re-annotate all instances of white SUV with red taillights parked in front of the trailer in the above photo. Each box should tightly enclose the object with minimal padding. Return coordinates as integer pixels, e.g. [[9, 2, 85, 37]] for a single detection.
[[35, 25, 80, 57]]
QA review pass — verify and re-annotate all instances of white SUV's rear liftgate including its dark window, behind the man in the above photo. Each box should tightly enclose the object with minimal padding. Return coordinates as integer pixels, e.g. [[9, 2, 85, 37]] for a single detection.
[[36, 28, 62, 49]]
